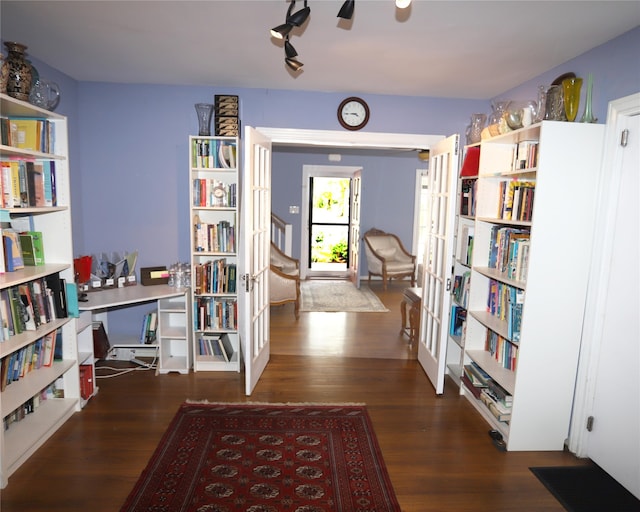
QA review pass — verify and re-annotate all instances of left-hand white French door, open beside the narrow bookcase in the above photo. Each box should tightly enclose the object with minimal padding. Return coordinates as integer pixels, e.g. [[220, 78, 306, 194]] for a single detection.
[[238, 126, 271, 395]]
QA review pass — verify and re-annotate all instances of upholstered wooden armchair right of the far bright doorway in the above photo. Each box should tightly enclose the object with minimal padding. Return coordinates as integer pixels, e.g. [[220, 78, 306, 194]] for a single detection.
[[362, 228, 416, 290]]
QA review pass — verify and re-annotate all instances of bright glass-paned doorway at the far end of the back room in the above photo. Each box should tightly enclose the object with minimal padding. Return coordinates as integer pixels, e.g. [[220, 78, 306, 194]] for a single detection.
[[300, 165, 361, 279]]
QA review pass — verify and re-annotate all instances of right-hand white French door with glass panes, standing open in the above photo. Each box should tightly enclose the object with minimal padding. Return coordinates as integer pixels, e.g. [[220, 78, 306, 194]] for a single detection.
[[418, 135, 459, 394]]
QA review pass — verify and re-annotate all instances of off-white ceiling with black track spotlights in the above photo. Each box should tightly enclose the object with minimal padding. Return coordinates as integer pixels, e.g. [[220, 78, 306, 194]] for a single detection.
[[0, 0, 640, 99]]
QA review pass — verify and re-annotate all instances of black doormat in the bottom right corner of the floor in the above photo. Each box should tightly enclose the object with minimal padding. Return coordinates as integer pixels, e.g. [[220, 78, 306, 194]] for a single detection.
[[529, 464, 640, 512]]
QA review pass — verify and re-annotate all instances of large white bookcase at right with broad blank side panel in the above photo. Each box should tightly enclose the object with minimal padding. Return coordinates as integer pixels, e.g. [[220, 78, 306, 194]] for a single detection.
[[460, 121, 604, 450]]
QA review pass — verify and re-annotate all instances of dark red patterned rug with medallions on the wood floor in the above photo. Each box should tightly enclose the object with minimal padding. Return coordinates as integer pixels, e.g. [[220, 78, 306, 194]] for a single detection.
[[121, 403, 400, 512]]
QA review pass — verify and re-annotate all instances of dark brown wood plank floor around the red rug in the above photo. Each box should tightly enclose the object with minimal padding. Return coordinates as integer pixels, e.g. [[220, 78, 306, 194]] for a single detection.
[[0, 282, 584, 512]]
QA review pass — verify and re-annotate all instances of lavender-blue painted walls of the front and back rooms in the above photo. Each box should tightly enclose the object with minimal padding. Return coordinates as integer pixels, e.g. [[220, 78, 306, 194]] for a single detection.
[[5, 28, 640, 332]]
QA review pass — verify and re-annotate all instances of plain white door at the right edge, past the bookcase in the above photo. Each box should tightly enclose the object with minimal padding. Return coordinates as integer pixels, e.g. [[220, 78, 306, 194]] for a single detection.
[[582, 107, 640, 498]]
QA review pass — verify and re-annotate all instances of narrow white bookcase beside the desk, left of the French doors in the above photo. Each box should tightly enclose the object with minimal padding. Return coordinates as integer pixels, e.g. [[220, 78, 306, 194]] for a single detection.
[[189, 136, 241, 372]]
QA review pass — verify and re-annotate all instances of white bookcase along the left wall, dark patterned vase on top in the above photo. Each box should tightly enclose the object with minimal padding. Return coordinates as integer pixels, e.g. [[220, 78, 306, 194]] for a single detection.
[[0, 94, 83, 487]]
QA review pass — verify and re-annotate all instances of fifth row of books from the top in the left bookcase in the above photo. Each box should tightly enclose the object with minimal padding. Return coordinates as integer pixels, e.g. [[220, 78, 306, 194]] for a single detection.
[[0, 329, 62, 391]]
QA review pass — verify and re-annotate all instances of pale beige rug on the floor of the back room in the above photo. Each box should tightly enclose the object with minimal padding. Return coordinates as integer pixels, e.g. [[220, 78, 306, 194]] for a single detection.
[[300, 279, 389, 313]]
